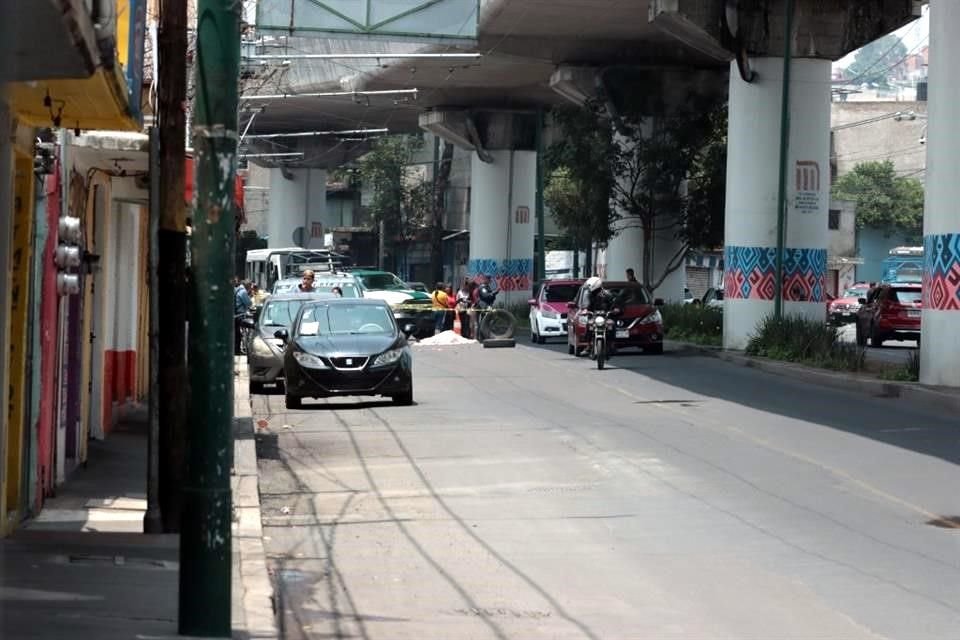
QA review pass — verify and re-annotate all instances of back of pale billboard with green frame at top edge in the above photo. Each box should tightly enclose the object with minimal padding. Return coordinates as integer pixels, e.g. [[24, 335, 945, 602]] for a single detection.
[[257, 0, 480, 44]]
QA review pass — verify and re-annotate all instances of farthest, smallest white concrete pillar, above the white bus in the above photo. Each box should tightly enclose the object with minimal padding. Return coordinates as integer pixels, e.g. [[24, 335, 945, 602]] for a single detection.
[[267, 169, 328, 249]]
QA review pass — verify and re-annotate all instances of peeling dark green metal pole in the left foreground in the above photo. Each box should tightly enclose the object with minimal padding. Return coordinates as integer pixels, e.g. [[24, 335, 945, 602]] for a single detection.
[[179, 0, 242, 637]]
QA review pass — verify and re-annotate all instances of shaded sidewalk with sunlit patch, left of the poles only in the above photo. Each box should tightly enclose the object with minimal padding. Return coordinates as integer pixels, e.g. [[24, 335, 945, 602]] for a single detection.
[[0, 408, 178, 640]]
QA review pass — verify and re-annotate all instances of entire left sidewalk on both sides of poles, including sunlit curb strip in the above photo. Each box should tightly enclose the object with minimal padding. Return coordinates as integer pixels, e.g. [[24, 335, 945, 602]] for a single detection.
[[0, 390, 277, 640]]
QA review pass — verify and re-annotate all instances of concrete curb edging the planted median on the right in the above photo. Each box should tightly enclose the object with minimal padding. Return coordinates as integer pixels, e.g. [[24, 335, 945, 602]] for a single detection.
[[664, 340, 960, 412]]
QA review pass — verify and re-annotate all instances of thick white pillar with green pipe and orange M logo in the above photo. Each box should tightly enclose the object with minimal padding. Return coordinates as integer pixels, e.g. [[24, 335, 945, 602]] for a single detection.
[[723, 58, 830, 349]]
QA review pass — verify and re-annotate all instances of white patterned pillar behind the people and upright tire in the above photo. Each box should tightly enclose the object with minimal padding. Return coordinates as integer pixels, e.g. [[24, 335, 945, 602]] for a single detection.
[[467, 149, 537, 304]]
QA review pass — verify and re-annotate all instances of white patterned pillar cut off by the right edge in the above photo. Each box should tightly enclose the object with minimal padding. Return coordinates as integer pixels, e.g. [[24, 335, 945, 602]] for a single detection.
[[920, 0, 960, 387]]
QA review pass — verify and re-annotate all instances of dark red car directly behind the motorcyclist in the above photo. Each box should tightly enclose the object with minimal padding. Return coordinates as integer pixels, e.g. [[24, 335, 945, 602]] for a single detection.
[[567, 282, 663, 355]]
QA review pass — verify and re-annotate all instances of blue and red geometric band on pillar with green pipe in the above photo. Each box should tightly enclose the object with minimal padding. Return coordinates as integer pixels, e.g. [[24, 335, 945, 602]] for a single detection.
[[723, 245, 827, 302]]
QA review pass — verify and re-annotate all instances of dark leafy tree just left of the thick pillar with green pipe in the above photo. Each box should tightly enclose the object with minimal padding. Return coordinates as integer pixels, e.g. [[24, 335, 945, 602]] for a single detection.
[[611, 98, 726, 294]]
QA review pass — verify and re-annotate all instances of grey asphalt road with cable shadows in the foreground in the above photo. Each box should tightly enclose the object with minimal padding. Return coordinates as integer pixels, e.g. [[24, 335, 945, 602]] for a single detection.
[[254, 344, 960, 640]]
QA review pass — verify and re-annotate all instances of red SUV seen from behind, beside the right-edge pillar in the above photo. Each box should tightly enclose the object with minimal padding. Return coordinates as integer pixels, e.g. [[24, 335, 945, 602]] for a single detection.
[[856, 283, 923, 347]]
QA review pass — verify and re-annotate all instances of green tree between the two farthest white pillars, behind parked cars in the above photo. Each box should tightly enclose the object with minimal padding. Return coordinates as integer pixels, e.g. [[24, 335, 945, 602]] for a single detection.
[[359, 135, 434, 270]]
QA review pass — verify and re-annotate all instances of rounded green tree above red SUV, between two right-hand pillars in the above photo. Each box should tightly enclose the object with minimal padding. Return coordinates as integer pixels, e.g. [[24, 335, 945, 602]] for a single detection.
[[833, 160, 924, 237]]
